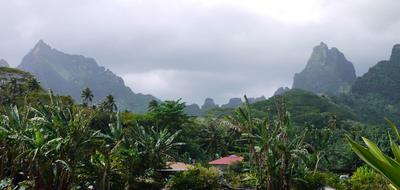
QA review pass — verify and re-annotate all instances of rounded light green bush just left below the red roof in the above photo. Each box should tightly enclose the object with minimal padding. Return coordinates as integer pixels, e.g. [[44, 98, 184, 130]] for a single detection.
[[167, 165, 220, 190]]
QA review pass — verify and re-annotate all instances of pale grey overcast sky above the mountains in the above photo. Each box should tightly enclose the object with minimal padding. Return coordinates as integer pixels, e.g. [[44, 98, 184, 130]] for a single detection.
[[0, 0, 400, 104]]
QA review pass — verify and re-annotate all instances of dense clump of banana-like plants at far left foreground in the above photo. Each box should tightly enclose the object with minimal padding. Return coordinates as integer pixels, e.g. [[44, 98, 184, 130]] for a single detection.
[[0, 91, 98, 189]]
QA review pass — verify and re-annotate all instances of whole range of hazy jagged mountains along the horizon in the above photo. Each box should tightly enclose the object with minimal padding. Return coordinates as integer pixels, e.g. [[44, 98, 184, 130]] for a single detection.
[[7, 40, 400, 116]]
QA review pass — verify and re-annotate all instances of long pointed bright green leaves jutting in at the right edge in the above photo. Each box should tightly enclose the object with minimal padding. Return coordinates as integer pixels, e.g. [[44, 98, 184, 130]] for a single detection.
[[346, 118, 400, 189]]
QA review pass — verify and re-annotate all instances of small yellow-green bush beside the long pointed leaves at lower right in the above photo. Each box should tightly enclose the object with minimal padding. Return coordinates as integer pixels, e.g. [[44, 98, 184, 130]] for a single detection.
[[349, 167, 389, 190]]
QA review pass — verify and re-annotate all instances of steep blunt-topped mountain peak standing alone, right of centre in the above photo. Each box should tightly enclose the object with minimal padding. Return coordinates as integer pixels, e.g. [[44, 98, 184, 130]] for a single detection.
[[292, 42, 356, 94]]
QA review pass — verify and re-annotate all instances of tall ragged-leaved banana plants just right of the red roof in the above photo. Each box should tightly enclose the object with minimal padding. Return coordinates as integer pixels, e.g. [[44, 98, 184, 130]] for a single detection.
[[228, 96, 308, 190]]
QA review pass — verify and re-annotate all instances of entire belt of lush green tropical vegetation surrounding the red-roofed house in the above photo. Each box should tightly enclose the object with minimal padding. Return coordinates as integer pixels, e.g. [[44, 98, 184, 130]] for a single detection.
[[0, 68, 398, 190]]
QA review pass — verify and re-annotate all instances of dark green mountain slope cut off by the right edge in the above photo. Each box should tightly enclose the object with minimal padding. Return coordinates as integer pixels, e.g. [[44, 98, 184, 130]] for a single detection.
[[352, 44, 400, 102]]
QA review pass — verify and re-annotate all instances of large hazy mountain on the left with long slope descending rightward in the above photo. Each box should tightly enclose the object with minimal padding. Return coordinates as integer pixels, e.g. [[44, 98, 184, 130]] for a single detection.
[[18, 40, 156, 112]]
